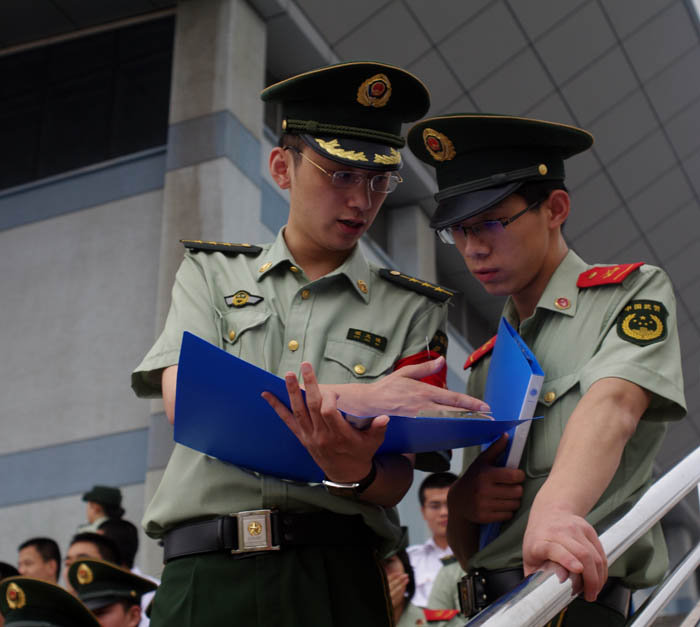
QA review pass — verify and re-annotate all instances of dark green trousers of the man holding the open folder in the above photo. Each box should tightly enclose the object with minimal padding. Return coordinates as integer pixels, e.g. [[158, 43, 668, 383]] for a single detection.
[[151, 547, 391, 627]]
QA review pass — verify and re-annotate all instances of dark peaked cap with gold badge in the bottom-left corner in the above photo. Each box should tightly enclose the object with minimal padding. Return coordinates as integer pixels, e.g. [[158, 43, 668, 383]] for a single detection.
[[0, 577, 100, 627]]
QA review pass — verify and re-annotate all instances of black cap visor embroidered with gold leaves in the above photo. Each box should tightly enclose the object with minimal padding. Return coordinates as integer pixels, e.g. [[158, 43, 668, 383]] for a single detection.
[[300, 134, 402, 172]]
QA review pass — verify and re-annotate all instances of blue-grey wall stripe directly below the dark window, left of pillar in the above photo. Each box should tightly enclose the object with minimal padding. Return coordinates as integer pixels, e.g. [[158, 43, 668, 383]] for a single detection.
[[0, 147, 165, 230]]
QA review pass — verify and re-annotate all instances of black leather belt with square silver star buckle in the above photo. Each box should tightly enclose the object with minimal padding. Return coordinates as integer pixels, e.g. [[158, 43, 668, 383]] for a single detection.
[[163, 509, 378, 563]]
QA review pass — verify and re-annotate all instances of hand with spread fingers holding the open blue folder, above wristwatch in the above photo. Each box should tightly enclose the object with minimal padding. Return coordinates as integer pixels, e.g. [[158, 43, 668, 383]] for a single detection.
[[262, 362, 389, 483]]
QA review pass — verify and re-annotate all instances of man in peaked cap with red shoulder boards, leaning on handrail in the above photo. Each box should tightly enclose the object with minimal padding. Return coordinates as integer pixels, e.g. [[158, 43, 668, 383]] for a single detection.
[[408, 114, 685, 625]]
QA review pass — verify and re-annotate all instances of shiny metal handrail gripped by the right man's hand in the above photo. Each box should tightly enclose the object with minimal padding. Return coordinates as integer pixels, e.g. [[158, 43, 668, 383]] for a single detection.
[[467, 447, 700, 627]]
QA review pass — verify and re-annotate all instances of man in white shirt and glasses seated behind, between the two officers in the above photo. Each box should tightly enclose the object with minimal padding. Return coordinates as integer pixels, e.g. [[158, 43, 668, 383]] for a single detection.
[[407, 472, 457, 607]]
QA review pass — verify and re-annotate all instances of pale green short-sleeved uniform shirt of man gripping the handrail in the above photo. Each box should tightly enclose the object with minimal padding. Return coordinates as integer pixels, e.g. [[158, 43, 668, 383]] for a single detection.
[[465, 251, 685, 588]]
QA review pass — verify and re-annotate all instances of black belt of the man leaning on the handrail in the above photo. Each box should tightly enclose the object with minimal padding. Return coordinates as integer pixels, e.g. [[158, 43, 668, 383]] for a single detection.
[[457, 568, 632, 617]]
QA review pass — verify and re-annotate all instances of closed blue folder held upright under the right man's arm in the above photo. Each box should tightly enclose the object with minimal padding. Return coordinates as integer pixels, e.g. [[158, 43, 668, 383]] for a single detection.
[[479, 318, 544, 548]]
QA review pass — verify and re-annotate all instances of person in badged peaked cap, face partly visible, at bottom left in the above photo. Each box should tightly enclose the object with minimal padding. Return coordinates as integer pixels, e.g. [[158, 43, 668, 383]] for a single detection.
[[68, 559, 158, 627]]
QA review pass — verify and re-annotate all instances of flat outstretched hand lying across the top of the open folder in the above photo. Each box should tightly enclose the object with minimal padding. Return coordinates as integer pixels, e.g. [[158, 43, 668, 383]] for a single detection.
[[331, 357, 489, 416]]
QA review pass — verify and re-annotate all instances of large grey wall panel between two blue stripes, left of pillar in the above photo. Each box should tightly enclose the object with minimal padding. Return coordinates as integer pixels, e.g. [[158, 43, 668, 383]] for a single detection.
[[0, 191, 162, 454]]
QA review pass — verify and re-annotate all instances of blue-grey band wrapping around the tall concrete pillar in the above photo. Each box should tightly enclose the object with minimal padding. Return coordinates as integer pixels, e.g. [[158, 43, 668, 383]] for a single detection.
[[166, 111, 261, 185]]
